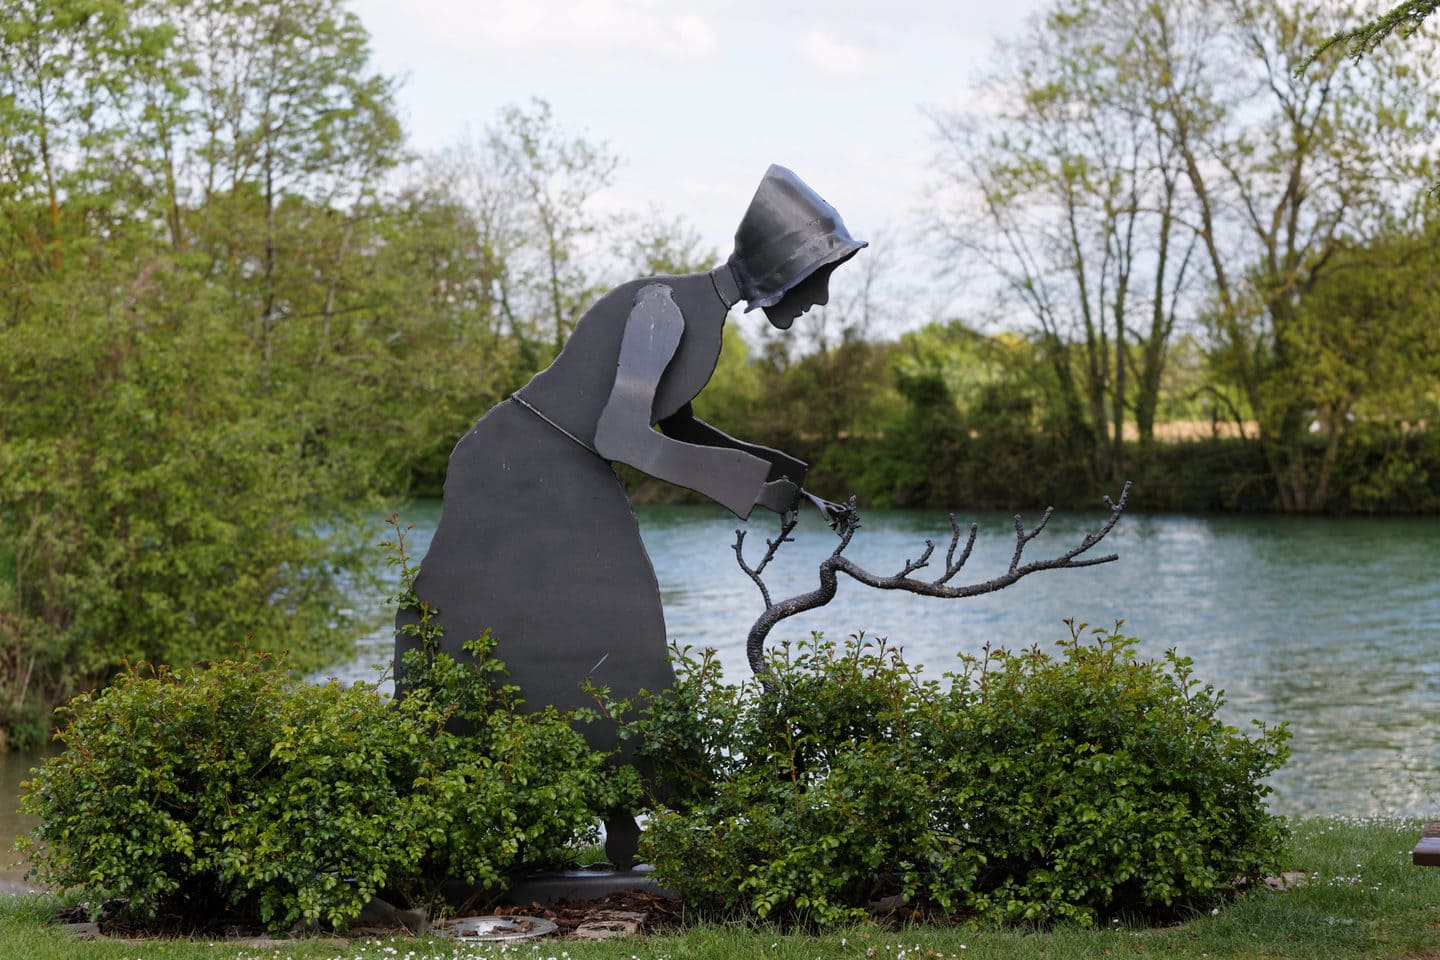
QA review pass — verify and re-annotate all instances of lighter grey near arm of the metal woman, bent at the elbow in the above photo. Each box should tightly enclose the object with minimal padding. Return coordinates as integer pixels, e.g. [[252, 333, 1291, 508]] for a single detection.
[[595, 284, 798, 518]]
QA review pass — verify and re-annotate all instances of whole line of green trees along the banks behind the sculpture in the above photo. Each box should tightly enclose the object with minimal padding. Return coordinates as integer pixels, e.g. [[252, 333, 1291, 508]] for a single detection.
[[0, 0, 1440, 741]]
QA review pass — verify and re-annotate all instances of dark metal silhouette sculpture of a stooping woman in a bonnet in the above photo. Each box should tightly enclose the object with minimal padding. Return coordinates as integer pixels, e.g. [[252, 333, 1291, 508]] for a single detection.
[[395, 166, 865, 868]]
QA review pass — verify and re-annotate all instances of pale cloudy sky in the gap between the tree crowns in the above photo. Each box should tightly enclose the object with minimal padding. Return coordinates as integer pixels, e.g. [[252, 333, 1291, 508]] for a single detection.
[[353, 0, 1043, 326]]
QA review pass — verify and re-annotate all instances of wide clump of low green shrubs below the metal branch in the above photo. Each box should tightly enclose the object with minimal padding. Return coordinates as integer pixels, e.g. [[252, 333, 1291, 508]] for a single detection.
[[628, 630, 1289, 924]]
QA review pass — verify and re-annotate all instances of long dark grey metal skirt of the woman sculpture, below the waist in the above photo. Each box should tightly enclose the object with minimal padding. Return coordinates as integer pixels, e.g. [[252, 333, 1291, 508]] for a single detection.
[[396, 400, 674, 750]]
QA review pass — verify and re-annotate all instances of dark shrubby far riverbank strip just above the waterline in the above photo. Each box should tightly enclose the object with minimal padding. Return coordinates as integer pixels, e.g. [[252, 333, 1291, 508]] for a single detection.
[[613, 425, 1440, 515]]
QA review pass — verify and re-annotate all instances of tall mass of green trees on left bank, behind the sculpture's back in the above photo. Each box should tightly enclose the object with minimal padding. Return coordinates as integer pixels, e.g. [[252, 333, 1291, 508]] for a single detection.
[[0, 0, 399, 737]]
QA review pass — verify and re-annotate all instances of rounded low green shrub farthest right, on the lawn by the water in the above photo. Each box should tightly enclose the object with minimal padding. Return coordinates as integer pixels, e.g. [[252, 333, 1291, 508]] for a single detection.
[[926, 632, 1289, 923]]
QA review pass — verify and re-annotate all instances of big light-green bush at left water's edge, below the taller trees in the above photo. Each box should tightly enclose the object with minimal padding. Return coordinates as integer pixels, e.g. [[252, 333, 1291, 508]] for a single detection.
[[0, 268, 377, 747]]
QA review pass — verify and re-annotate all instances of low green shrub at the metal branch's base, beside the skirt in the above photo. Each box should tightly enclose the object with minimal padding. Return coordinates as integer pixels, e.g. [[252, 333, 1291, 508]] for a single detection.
[[626, 645, 963, 923]]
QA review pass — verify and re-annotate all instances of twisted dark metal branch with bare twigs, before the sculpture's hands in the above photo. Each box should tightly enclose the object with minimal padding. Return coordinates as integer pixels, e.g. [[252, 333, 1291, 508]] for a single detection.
[[733, 482, 1130, 689]]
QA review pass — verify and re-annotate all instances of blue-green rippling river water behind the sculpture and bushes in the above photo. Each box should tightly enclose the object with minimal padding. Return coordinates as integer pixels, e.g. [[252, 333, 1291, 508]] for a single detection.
[[0, 501, 1440, 879]]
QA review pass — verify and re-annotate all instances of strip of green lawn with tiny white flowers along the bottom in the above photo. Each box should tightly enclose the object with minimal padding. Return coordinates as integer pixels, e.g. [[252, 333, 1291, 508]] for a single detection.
[[0, 820, 1440, 960]]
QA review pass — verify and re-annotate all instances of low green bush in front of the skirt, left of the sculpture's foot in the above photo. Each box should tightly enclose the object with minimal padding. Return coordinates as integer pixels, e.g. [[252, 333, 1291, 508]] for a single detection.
[[22, 638, 632, 930]]
